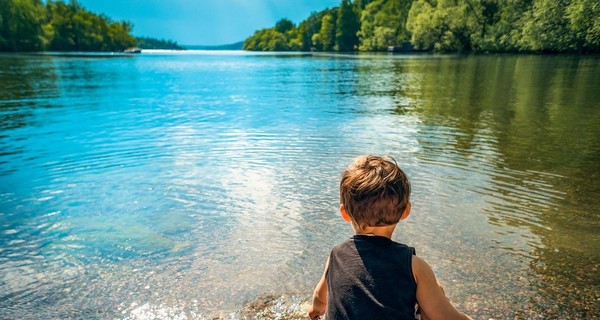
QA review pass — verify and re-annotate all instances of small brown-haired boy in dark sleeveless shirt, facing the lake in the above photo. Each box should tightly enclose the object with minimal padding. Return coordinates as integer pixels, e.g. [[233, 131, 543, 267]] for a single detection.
[[308, 155, 472, 320]]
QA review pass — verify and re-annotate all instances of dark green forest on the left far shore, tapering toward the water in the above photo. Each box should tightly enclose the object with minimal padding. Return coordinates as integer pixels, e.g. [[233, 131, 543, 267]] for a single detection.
[[0, 0, 183, 52]]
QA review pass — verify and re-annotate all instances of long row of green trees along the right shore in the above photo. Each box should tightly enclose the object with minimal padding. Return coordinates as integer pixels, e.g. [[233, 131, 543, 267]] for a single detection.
[[244, 0, 600, 52]]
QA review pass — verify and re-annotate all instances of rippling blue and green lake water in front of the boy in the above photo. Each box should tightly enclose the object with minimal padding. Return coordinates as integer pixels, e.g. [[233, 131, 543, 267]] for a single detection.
[[0, 51, 600, 319]]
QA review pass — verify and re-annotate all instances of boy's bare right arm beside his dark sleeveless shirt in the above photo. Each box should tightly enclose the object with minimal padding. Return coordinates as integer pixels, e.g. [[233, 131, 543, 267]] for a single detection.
[[412, 256, 473, 320]]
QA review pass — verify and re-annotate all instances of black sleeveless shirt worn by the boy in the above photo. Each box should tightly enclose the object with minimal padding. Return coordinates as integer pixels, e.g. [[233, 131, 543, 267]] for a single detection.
[[325, 235, 417, 320]]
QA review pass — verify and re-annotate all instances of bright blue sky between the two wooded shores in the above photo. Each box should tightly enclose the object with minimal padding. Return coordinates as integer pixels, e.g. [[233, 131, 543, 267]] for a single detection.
[[79, 0, 341, 45]]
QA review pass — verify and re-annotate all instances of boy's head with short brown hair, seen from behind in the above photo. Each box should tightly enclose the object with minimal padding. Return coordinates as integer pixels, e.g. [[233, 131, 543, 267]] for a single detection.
[[340, 155, 410, 229]]
